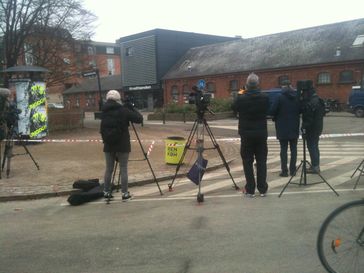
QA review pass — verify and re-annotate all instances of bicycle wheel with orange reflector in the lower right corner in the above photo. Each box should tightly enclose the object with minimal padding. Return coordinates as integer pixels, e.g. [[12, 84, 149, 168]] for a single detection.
[[317, 199, 364, 273]]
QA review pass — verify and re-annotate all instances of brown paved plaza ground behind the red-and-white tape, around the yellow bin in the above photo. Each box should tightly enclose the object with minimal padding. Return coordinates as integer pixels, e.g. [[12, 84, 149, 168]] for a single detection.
[[0, 119, 238, 202]]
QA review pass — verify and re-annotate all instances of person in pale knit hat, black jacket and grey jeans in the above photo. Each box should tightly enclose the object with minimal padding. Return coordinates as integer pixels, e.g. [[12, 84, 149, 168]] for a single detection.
[[100, 90, 143, 201]]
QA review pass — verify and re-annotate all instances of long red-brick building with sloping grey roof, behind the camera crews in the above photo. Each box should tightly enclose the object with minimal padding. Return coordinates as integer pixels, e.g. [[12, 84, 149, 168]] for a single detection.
[[163, 19, 364, 104]]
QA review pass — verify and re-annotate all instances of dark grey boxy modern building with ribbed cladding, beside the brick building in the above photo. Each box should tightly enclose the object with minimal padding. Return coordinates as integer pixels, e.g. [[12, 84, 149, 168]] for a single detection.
[[117, 29, 236, 111]]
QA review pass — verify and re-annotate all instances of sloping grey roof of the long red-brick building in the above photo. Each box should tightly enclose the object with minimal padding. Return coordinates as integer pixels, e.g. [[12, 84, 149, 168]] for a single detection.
[[163, 19, 364, 79]]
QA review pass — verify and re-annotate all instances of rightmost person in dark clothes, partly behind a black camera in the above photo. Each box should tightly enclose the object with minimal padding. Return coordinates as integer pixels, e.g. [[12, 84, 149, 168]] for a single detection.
[[301, 81, 325, 173]]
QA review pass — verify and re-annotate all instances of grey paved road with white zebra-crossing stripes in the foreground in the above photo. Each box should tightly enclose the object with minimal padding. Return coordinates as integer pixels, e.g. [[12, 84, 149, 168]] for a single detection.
[[0, 111, 364, 273]]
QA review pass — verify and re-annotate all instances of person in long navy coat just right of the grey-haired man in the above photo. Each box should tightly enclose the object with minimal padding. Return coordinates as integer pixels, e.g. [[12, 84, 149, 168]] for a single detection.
[[270, 80, 300, 177]]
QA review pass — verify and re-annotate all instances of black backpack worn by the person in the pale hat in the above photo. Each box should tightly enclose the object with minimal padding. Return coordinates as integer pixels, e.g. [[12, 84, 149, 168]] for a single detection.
[[101, 112, 122, 145]]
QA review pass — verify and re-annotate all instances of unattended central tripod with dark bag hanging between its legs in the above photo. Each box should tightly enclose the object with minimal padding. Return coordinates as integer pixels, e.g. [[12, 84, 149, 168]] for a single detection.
[[168, 111, 239, 203]]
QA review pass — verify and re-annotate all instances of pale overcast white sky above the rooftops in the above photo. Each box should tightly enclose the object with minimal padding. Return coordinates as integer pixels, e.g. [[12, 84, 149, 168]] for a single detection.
[[84, 0, 364, 42]]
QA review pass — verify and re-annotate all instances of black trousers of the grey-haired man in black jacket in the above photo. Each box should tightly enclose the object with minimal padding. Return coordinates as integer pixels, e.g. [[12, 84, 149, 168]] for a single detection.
[[240, 137, 268, 194]]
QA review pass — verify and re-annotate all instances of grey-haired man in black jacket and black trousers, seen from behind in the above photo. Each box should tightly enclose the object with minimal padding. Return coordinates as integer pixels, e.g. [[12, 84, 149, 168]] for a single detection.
[[233, 73, 269, 197]]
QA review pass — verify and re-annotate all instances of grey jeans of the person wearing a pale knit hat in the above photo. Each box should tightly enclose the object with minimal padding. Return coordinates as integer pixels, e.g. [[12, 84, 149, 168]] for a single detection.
[[104, 152, 129, 193]]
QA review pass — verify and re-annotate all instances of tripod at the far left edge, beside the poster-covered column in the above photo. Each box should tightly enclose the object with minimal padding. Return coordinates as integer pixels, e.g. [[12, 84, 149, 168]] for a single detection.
[[0, 126, 39, 179]]
